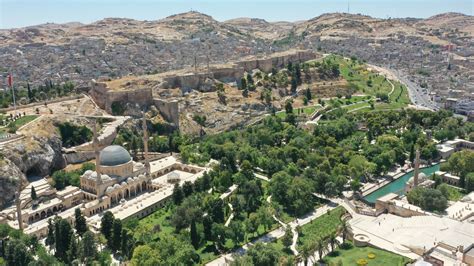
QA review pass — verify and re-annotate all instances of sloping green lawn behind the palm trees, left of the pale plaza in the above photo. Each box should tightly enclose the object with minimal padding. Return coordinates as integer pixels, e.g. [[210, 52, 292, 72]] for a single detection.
[[297, 206, 346, 250]]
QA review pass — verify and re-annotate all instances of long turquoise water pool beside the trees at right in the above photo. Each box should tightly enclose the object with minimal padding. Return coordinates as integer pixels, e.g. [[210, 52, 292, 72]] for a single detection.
[[364, 164, 439, 203]]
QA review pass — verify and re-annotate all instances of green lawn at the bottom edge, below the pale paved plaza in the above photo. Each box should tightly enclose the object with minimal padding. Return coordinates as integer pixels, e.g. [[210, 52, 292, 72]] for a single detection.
[[323, 245, 411, 266]]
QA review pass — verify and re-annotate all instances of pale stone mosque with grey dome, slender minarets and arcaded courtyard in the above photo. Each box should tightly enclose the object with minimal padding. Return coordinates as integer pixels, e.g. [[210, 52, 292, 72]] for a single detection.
[[0, 114, 207, 238]]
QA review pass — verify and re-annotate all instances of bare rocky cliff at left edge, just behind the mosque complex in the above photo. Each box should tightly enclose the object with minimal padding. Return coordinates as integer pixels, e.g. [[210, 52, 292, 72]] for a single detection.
[[0, 119, 65, 205]]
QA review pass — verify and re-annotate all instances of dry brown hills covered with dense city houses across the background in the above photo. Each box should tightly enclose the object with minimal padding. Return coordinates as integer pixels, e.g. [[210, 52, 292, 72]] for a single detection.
[[0, 12, 474, 96]]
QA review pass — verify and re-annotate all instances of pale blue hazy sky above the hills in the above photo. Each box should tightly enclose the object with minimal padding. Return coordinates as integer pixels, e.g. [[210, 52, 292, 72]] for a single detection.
[[0, 0, 474, 29]]
